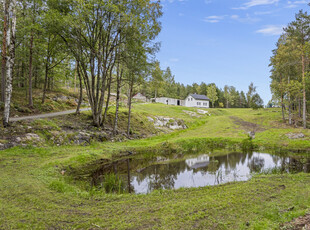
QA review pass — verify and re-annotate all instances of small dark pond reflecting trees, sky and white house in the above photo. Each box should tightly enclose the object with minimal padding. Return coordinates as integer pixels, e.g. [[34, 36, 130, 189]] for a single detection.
[[95, 152, 310, 194]]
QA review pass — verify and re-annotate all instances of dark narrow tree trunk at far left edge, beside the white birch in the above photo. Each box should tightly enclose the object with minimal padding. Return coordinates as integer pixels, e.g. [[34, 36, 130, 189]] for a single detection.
[[1, 1, 8, 102]]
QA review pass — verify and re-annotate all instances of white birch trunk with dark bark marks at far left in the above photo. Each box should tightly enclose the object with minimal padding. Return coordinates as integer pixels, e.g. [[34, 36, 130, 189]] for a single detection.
[[3, 0, 16, 127]]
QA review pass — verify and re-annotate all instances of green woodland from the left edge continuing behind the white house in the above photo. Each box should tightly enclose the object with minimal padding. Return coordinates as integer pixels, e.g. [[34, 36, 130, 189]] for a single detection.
[[0, 0, 263, 127]]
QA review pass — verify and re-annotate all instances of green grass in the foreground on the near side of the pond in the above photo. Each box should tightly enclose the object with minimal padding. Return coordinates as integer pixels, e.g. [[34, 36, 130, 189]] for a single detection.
[[0, 146, 310, 229]]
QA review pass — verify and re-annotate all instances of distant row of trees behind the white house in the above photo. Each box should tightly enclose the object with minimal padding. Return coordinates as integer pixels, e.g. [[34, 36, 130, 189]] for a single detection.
[[139, 62, 264, 108]]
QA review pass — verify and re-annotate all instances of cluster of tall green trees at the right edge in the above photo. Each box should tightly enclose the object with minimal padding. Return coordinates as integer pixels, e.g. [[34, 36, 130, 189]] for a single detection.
[[269, 5, 310, 128]]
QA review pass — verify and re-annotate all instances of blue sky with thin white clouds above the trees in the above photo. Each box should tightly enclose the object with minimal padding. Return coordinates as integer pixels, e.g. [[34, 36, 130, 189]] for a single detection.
[[157, 0, 310, 104]]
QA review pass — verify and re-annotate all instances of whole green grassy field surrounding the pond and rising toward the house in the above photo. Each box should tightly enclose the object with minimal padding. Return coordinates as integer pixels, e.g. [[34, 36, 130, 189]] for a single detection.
[[0, 104, 310, 229]]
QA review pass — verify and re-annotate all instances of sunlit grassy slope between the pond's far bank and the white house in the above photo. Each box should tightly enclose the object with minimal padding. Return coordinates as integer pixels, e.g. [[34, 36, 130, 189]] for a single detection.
[[135, 105, 310, 150]]
